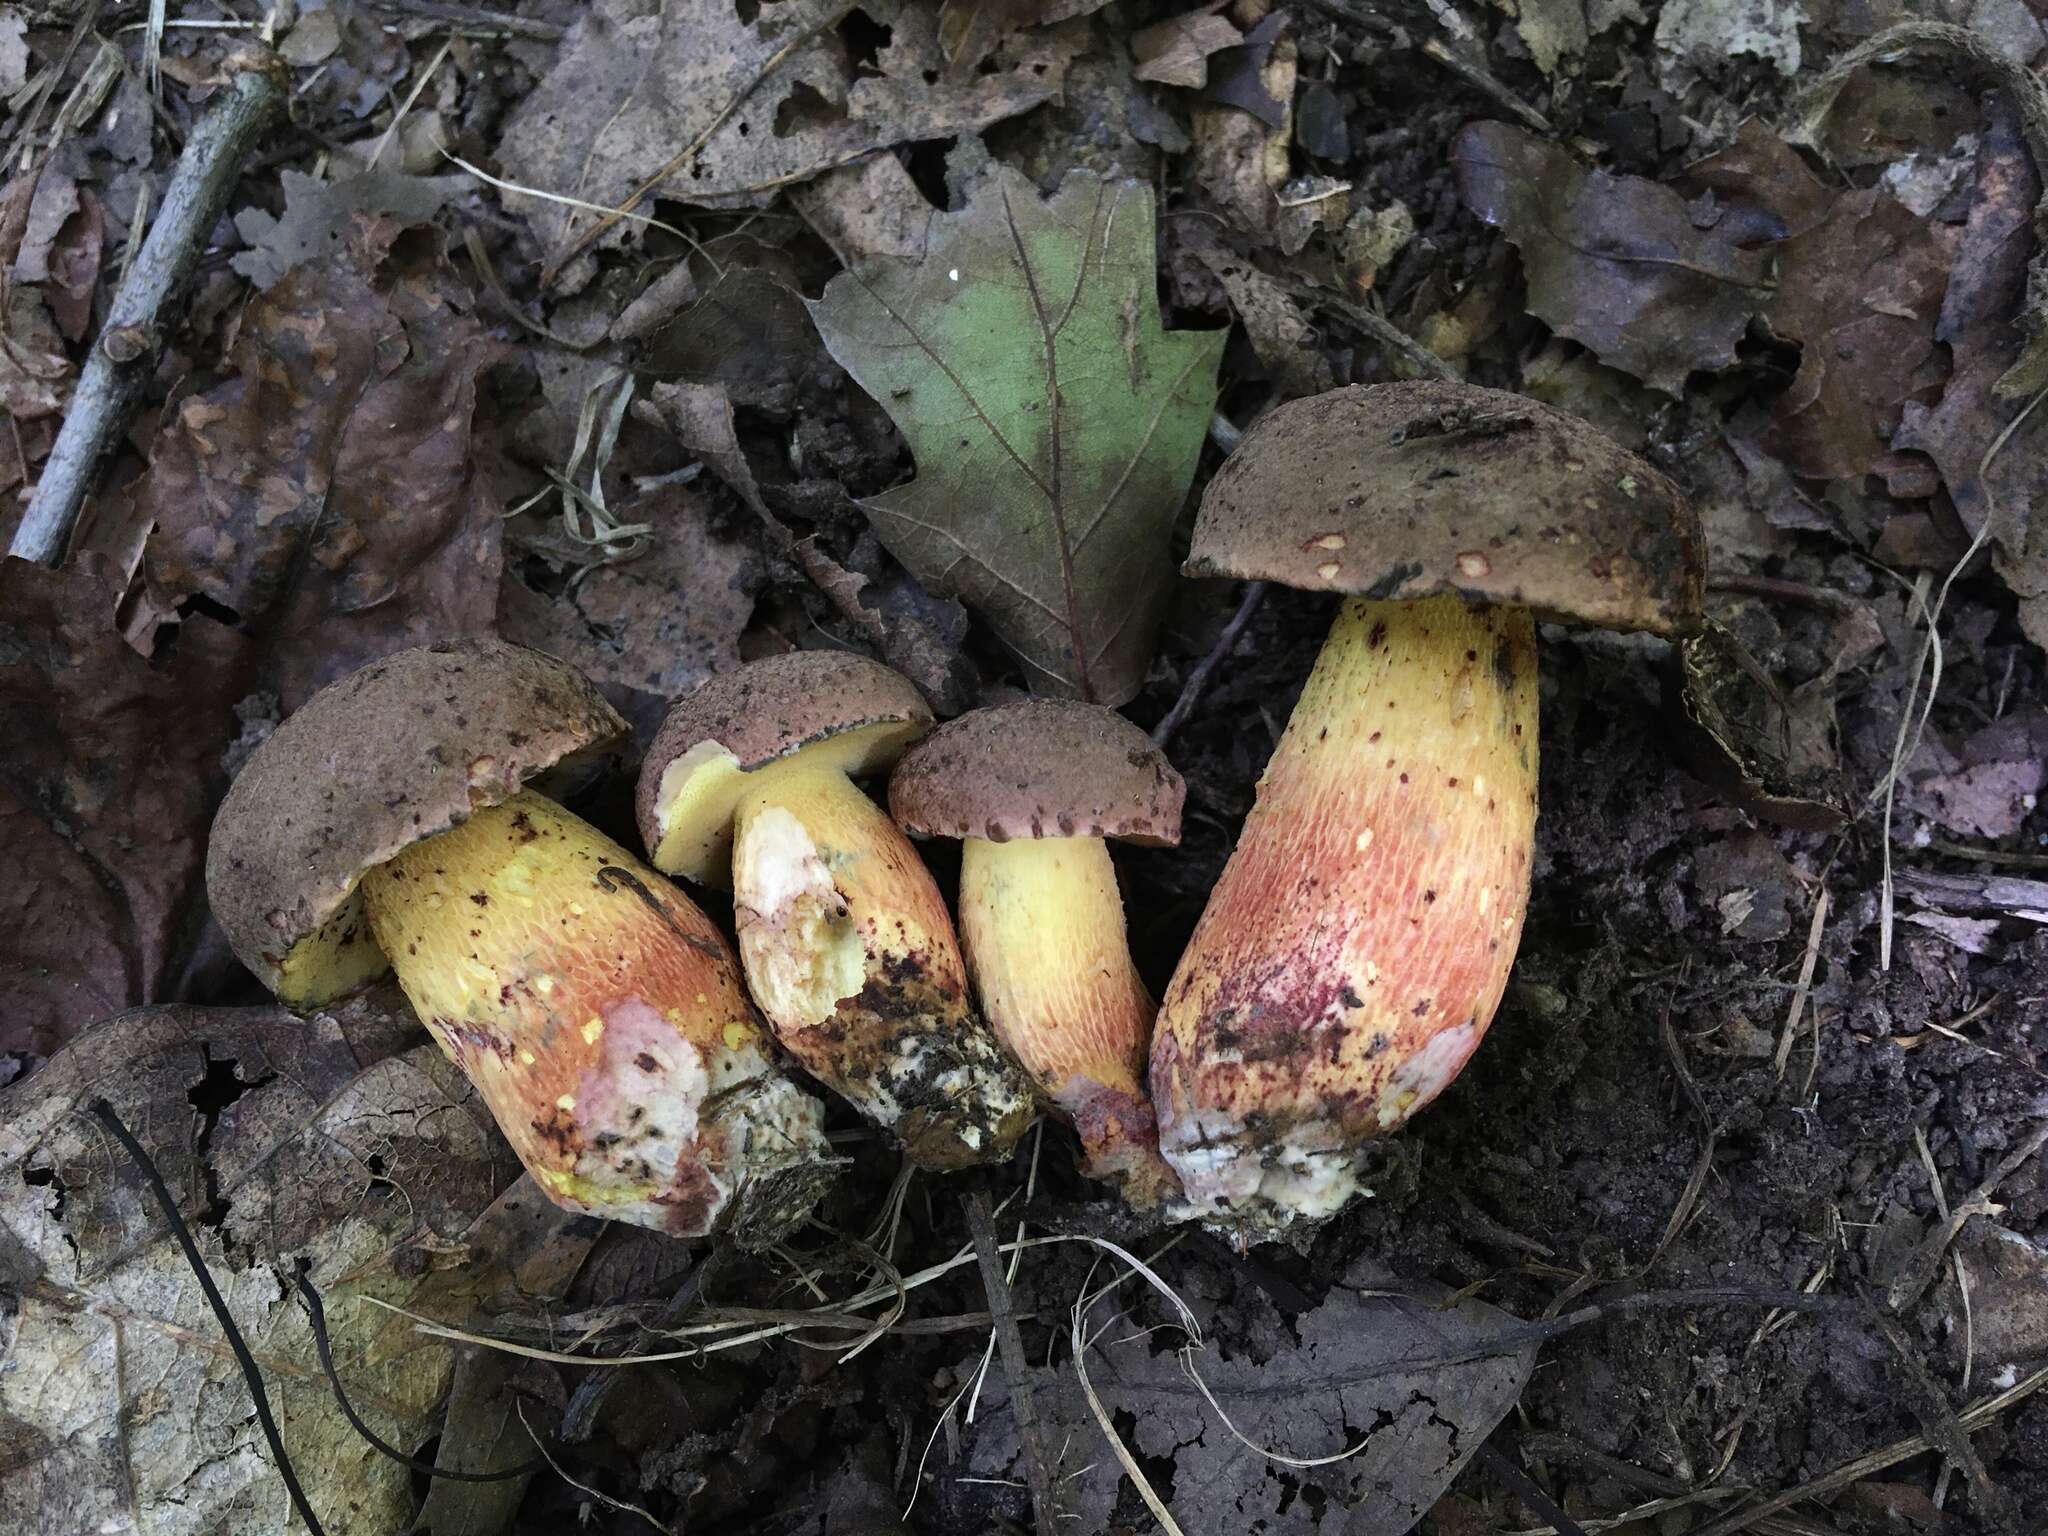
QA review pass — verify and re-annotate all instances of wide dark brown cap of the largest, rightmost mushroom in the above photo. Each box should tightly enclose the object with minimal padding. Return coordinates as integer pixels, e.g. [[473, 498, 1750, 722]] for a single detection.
[[1184, 381, 1706, 635]]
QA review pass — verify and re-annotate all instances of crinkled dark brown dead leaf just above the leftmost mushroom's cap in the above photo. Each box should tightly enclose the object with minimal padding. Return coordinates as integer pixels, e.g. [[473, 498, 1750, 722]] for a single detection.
[[135, 223, 500, 711]]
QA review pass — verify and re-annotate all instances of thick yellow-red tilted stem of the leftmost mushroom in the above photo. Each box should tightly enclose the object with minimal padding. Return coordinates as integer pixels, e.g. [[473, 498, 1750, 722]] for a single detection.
[[362, 793, 831, 1243]]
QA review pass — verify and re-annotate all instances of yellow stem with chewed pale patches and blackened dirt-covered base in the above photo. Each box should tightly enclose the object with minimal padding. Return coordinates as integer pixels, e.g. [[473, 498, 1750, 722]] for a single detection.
[[733, 754, 1034, 1167]]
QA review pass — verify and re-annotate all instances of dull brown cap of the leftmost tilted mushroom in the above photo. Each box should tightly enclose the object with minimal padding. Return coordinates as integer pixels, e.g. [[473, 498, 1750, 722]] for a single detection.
[[207, 639, 627, 1008]]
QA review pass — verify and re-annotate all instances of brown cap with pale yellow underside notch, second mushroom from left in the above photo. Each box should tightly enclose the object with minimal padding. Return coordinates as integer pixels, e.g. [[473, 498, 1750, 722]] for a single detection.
[[635, 651, 932, 883]]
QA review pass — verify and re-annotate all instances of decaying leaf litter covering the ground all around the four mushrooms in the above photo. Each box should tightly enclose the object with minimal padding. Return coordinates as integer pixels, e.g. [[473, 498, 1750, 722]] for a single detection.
[[0, 0, 2048, 1532]]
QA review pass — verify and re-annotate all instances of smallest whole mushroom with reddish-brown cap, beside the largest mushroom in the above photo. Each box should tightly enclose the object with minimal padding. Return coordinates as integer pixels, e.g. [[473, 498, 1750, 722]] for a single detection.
[[889, 700, 1186, 1206]]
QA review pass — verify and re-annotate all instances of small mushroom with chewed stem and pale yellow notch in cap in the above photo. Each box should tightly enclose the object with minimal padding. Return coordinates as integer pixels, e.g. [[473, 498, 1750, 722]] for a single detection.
[[639, 651, 1036, 1167]]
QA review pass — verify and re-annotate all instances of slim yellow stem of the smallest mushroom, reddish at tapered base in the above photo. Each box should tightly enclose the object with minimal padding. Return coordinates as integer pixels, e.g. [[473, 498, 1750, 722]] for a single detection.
[[961, 838, 1180, 1206]]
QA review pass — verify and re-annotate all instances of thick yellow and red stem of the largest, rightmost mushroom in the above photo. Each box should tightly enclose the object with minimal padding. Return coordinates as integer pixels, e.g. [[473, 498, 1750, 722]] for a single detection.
[[1151, 598, 1536, 1237]]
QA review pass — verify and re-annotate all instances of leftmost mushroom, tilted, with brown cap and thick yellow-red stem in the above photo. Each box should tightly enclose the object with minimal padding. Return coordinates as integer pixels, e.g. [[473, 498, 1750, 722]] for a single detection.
[[207, 639, 834, 1243]]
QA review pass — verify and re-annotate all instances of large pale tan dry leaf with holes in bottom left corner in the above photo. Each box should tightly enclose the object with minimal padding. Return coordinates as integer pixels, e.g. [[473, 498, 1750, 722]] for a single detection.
[[0, 995, 518, 1536]]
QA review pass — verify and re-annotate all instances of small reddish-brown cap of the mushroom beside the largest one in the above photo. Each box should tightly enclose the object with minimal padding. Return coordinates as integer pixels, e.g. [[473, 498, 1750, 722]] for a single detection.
[[889, 698, 1188, 846]]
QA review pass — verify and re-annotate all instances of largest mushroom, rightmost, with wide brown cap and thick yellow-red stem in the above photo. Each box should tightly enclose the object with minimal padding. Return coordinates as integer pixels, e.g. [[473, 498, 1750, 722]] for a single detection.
[[1151, 383, 1706, 1239]]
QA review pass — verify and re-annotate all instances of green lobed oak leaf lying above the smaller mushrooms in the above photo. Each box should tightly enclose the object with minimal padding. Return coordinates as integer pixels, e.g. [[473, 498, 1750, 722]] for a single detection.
[[811, 168, 1225, 705]]
